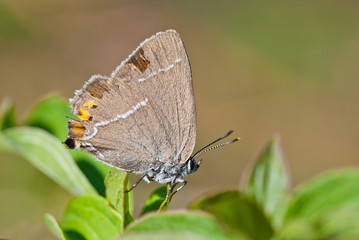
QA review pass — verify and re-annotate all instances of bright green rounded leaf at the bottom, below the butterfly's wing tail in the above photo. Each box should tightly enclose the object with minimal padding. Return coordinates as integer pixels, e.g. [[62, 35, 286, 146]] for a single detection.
[[60, 195, 122, 240]]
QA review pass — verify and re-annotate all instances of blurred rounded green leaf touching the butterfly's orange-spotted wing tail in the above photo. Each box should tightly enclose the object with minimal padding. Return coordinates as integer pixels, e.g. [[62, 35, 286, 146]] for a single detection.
[[25, 96, 73, 141]]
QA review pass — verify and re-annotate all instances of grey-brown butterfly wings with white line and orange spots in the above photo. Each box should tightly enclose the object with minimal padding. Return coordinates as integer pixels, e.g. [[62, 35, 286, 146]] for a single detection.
[[67, 30, 196, 173]]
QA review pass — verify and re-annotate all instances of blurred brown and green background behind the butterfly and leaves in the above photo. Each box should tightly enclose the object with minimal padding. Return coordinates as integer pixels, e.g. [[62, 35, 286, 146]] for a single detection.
[[0, 0, 359, 239]]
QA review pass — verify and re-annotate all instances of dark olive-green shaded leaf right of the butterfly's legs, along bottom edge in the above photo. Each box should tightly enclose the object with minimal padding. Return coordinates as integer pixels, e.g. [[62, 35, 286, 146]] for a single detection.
[[190, 190, 273, 240]]
